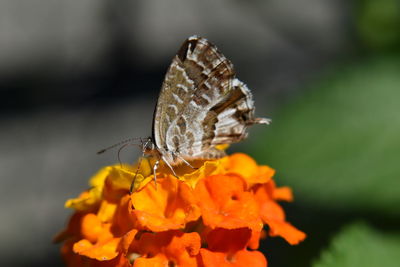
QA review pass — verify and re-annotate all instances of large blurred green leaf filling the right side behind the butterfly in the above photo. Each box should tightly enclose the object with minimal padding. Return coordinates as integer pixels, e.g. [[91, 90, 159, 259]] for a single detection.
[[250, 57, 400, 215]]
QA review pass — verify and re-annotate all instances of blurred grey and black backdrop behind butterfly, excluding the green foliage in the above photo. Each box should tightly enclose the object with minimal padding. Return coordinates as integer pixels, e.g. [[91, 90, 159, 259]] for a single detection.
[[0, 0, 356, 266]]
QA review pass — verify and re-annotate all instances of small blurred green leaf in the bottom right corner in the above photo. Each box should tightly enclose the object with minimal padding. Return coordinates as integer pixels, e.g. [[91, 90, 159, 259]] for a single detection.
[[313, 223, 400, 267]]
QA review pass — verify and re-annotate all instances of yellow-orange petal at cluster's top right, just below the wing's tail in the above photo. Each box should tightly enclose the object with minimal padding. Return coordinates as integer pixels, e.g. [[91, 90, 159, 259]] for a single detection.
[[223, 153, 275, 188]]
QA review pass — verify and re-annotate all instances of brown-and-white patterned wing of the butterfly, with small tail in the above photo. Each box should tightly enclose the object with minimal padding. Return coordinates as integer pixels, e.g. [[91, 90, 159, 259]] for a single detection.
[[153, 36, 268, 164]]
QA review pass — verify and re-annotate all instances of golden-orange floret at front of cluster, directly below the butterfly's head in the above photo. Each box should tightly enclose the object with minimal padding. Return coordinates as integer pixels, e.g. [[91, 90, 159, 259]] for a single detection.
[[131, 177, 200, 232]]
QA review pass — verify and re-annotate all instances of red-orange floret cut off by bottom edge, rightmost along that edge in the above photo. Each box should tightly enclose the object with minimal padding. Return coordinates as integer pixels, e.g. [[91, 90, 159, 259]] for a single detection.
[[200, 248, 267, 267]]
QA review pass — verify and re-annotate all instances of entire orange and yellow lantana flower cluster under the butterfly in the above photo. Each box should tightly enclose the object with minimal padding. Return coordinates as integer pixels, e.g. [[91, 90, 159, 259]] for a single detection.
[[56, 153, 306, 267]]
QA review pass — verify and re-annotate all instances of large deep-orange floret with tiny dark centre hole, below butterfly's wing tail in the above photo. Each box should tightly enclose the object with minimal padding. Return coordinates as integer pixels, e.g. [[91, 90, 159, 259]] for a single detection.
[[195, 175, 262, 231]]
